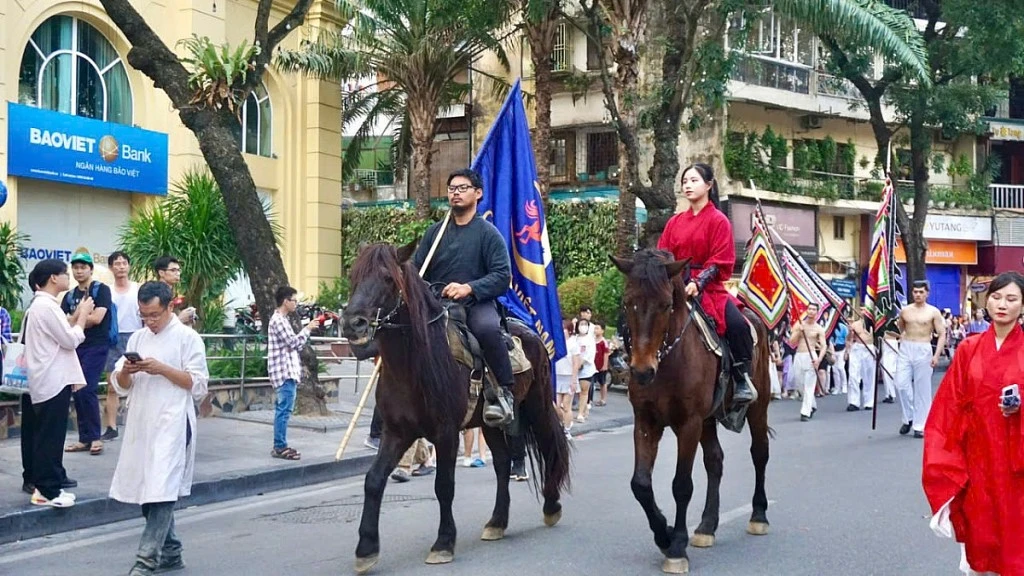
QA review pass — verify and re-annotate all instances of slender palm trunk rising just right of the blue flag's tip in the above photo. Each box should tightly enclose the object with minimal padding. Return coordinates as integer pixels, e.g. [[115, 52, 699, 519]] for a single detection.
[[526, 19, 555, 207]]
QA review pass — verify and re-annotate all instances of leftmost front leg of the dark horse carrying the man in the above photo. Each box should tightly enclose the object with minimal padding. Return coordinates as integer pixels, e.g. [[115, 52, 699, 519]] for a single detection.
[[355, 434, 414, 574]]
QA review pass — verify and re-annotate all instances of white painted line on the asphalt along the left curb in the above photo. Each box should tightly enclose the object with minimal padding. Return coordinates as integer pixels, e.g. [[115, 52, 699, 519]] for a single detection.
[[0, 480, 362, 566]]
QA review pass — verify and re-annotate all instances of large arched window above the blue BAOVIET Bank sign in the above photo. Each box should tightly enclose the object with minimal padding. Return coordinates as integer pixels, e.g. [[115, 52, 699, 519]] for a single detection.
[[17, 15, 132, 124]]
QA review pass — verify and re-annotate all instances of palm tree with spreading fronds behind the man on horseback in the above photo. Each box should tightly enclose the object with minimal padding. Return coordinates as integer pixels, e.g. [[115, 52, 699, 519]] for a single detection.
[[278, 0, 508, 218]]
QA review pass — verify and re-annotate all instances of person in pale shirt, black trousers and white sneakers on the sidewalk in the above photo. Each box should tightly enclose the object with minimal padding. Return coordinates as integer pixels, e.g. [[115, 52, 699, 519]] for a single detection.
[[22, 259, 94, 508]]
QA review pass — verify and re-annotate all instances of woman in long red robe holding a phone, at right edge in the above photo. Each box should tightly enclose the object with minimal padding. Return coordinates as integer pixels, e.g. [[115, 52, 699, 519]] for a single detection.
[[922, 272, 1024, 575]]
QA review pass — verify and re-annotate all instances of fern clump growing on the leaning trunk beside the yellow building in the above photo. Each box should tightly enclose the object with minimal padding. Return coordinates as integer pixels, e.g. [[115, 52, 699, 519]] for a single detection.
[[178, 34, 260, 114]]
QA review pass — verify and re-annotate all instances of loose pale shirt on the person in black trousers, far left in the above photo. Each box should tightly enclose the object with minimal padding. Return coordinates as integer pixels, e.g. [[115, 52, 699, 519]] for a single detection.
[[22, 291, 85, 404]]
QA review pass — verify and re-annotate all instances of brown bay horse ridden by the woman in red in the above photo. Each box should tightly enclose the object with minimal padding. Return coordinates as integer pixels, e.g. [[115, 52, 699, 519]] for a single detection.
[[611, 249, 771, 574]]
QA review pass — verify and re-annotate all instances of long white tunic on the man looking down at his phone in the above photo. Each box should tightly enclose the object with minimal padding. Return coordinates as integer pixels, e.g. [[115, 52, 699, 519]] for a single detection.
[[111, 315, 210, 504]]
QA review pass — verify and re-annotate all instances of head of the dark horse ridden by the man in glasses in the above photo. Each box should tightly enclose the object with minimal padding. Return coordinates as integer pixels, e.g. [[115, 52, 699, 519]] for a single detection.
[[341, 240, 418, 346]]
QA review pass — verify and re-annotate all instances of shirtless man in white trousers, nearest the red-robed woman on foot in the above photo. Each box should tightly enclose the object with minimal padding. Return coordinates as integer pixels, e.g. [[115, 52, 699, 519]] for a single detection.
[[896, 280, 946, 438]]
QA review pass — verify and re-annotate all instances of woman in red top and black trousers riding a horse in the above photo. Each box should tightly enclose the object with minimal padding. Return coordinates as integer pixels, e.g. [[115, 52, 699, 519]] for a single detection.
[[657, 163, 758, 404]]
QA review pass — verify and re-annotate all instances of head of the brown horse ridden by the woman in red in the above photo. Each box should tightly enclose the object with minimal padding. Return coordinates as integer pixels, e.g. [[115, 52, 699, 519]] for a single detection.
[[611, 249, 690, 384]]
